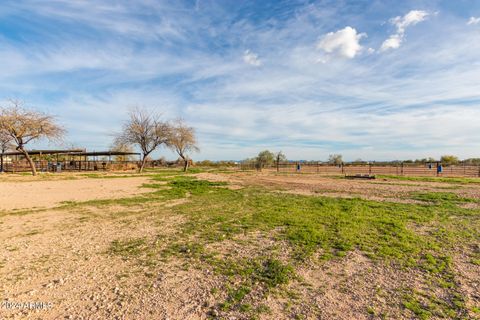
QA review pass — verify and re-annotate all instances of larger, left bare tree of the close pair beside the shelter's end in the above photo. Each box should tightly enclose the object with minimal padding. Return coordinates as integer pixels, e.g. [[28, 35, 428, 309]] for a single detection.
[[115, 108, 170, 172]]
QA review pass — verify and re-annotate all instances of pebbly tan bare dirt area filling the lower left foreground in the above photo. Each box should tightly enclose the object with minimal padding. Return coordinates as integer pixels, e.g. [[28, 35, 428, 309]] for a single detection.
[[0, 205, 221, 319]]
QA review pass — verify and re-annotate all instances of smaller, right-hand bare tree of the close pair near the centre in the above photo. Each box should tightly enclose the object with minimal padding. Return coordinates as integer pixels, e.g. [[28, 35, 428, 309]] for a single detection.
[[167, 119, 200, 172]]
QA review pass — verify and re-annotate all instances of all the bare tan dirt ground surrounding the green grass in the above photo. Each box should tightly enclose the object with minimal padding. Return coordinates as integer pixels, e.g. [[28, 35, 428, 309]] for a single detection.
[[0, 173, 480, 320]]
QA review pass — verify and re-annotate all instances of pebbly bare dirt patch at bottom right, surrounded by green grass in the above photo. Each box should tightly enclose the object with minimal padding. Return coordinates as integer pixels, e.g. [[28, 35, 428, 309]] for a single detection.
[[269, 251, 419, 320]]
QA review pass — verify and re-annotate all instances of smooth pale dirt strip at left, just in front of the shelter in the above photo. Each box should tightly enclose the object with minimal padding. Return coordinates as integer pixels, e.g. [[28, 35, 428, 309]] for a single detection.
[[0, 177, 151, 210]]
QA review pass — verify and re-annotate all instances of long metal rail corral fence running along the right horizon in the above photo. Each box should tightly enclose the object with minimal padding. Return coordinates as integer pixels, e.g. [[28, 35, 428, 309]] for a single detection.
[[239, 162, 480, 177]]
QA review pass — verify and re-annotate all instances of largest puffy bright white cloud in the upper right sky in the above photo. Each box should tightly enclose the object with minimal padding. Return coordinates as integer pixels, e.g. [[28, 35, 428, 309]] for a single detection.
[[317, 27, 366, 59]]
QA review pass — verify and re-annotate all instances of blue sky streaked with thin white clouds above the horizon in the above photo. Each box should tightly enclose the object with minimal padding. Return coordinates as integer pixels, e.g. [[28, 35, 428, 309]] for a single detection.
[[0, 0, 480, 160]]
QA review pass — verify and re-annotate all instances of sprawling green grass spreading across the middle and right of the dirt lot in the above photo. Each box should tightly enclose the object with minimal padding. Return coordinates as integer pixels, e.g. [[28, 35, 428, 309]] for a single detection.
[[96, 174, 480, 319]]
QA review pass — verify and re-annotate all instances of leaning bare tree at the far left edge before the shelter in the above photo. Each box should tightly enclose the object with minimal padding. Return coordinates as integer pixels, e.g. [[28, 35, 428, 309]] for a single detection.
[[0, 100, 65, 176]]
